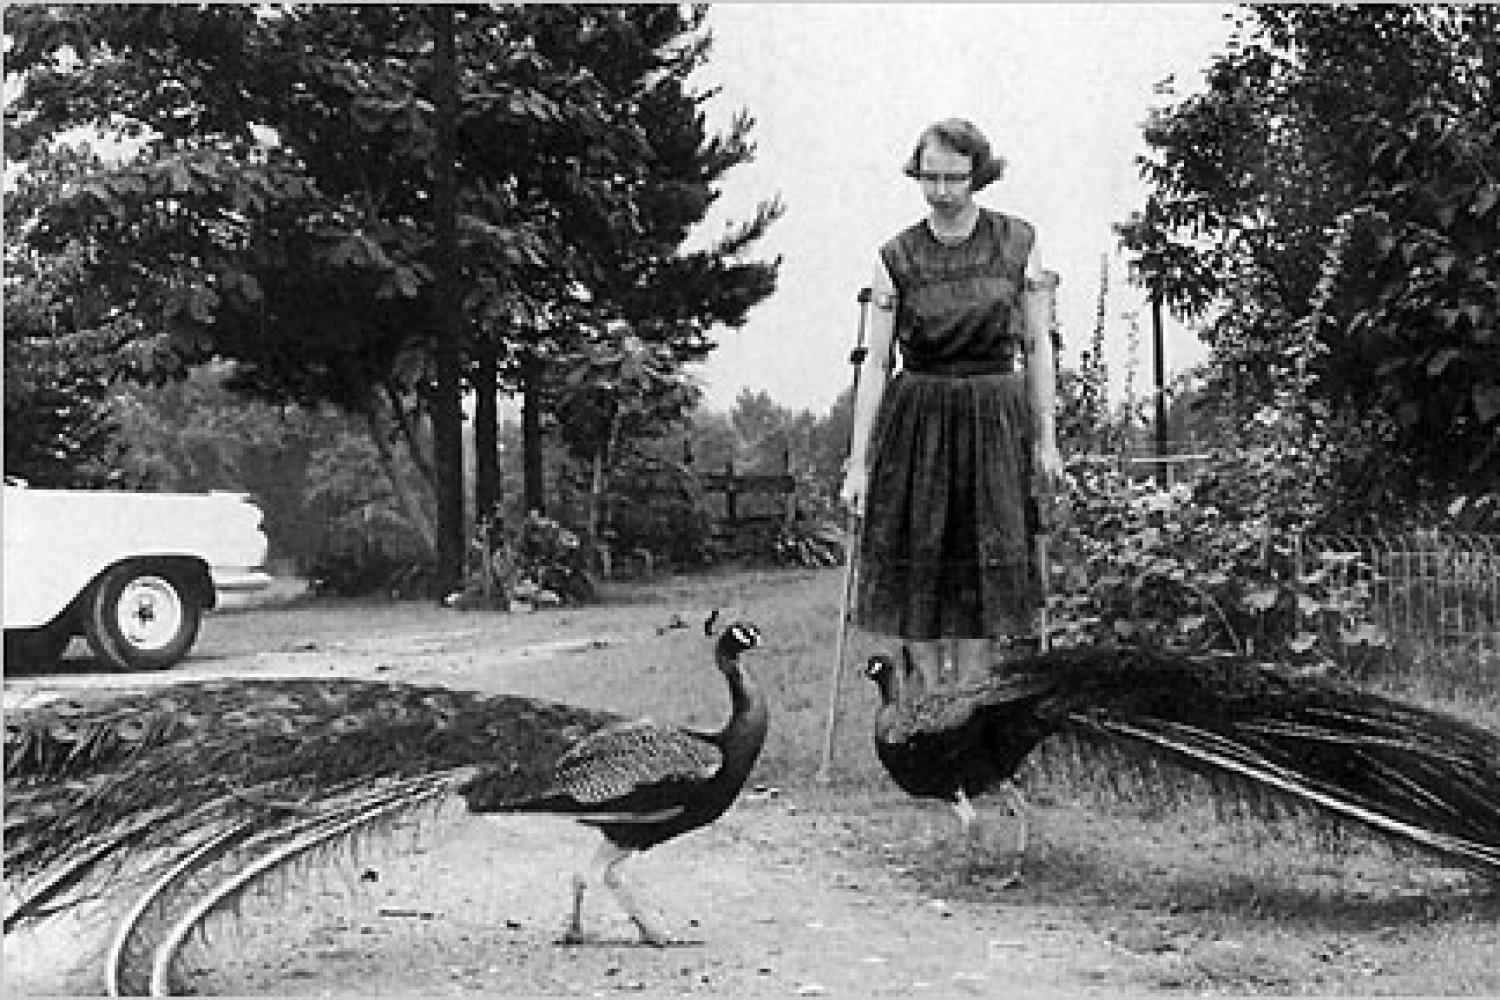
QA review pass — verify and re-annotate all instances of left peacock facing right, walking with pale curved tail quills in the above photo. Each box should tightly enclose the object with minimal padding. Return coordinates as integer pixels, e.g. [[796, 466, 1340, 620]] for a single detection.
[[5, 622, 768, 996]]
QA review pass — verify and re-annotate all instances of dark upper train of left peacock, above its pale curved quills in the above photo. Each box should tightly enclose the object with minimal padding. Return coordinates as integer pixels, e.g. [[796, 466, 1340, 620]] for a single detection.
[[5, 679, 623, 931]]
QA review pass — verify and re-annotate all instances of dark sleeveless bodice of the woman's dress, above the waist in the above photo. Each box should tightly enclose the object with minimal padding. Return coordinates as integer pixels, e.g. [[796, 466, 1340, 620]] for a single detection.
[[881, 208, 1035, 375]]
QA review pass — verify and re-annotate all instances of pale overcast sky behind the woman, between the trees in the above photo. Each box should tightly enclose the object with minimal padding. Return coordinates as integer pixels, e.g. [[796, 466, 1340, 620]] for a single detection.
[[696, 3, 1232, 412]]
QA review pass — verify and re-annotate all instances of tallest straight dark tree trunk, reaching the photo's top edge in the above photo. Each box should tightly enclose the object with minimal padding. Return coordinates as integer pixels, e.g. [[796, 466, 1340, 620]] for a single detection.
[[432, 4, 465, 597]]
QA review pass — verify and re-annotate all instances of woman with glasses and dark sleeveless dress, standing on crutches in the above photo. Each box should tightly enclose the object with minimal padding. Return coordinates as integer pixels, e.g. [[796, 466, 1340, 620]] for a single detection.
[[843, 118, 1062, 682]]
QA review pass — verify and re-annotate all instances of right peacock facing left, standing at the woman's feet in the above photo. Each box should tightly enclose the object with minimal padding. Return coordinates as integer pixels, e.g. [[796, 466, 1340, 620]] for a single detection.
[[866, 646, 1500, 873]]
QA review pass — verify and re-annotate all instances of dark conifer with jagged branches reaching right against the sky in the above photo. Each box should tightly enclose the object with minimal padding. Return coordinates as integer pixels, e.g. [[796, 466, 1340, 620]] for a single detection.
[[513, 6, 782, 521]]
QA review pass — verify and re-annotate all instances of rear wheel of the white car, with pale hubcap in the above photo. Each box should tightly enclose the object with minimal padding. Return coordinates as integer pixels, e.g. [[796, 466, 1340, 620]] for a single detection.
[[84, 565, 203, 670]]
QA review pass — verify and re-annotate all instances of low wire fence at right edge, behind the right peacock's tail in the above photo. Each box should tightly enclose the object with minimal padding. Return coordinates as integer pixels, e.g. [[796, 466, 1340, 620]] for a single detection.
[[1296, 532, 1500, 651]]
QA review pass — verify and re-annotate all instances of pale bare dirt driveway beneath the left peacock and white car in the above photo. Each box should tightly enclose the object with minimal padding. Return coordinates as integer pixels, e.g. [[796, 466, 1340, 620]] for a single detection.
[[6, 581, 1134, 997]]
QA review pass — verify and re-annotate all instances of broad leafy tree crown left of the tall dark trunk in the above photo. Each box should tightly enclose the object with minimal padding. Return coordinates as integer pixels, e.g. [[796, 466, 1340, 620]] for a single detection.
[[8, 6, 498, 578]]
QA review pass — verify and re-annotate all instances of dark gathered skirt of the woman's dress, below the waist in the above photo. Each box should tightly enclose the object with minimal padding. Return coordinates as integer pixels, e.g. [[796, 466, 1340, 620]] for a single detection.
[[854, 372, 1041, 642]]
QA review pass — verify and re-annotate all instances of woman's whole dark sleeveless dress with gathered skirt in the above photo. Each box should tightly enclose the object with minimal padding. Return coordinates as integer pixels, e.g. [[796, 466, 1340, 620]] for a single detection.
[[855, 210, 1041, 642]]
